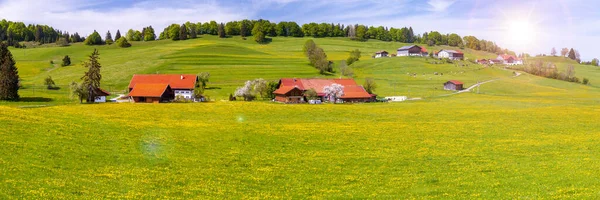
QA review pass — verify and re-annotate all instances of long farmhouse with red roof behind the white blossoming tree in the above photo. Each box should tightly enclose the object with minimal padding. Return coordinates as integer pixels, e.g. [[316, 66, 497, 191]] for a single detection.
[[273, 78, 374, 103]]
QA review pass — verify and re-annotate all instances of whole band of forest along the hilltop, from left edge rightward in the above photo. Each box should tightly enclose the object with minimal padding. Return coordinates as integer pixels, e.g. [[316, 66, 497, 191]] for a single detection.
[[0, 19, 516, 55]]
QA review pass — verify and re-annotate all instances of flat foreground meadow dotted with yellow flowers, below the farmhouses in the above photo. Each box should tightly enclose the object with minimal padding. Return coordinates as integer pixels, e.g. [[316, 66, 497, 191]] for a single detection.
[[0, 94, 600, 199]]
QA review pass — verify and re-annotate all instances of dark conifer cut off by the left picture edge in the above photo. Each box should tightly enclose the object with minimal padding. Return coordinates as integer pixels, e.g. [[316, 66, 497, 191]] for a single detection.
[[0, 42, 19, 101]]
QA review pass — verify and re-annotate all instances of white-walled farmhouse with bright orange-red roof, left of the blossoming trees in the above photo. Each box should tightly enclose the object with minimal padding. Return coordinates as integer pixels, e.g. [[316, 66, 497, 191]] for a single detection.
[[129, 74, 198, 103]]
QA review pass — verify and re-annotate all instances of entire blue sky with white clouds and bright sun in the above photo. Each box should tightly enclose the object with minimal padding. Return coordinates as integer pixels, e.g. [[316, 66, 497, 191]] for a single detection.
[[0, 0, 600, 60]]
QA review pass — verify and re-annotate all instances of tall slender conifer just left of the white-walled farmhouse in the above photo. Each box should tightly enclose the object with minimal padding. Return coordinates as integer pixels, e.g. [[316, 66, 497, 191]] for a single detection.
[[81, 49, 102, 103]]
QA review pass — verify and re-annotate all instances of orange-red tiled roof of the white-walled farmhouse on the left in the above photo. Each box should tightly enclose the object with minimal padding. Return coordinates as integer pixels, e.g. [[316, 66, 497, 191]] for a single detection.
[[129, 74, 197, 89]]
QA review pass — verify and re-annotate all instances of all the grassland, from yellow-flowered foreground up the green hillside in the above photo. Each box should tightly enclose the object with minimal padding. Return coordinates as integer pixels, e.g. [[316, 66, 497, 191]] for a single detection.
[[0, 36, 600, 199]]
